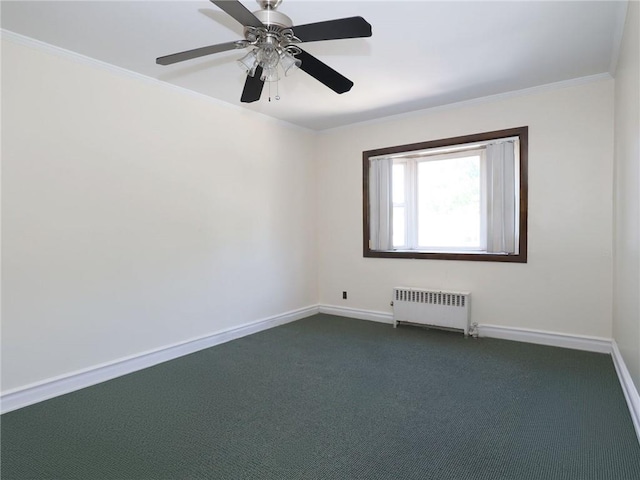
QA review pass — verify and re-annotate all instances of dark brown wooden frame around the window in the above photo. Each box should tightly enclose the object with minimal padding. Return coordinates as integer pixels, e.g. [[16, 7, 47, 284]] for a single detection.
[[362, 127, 529, 263]]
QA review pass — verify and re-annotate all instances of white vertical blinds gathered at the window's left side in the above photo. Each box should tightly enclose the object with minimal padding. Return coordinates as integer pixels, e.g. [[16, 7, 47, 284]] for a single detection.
[[369, 157, 393, 250]]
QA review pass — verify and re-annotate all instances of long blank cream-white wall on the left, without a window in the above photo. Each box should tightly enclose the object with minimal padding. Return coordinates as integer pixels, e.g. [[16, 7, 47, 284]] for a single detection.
[[2, 41, 317, 391]]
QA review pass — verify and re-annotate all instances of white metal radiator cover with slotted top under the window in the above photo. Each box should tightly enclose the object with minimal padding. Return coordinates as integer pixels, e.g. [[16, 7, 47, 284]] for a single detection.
[[392, 287, 476, 336]]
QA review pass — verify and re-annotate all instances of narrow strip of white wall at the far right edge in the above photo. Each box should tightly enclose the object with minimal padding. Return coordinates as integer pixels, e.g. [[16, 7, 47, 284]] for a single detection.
[[613, 2, 640, 389]]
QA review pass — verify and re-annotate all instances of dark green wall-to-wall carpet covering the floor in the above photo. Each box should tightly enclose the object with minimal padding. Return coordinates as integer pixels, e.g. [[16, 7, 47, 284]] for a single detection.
[[1, 315, 640, 480]]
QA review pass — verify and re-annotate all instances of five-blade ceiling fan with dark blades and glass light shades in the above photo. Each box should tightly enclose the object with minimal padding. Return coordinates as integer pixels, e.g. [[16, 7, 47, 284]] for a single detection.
[[156, 0, 371, 103]]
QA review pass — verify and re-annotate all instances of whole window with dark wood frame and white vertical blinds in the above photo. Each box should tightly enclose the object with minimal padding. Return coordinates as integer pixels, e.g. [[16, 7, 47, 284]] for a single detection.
[[363, 127, 528, 263]]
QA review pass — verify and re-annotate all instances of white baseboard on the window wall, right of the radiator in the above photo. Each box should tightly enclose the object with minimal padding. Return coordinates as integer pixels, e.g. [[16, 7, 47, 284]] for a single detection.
[[478, 324, 611, 353]]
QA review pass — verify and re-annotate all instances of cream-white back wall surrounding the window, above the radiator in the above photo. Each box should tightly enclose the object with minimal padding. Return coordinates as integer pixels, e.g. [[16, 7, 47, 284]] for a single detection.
[[318, 79, 613, 338]]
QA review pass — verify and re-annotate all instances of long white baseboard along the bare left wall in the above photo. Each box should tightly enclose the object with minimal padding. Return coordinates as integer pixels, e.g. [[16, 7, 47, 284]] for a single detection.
[[0, 306, 319, 413]]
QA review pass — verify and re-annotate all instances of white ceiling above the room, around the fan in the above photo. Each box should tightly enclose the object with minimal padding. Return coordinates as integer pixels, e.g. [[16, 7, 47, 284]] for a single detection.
[[1, 0, 626, 130]]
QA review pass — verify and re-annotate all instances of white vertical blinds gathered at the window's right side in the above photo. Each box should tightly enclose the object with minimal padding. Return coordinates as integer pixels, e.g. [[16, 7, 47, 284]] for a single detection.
[[486, 140, 517, 253]]
